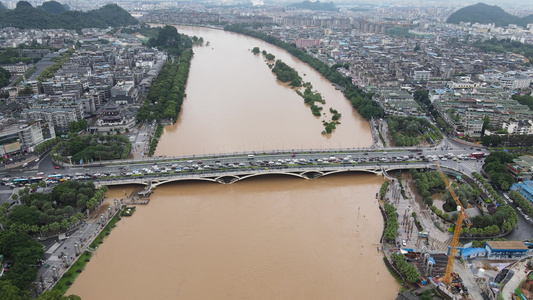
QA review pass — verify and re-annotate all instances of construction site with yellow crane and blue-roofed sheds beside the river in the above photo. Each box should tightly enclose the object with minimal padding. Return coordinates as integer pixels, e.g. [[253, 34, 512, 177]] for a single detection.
[[382, 164, 533, 300]]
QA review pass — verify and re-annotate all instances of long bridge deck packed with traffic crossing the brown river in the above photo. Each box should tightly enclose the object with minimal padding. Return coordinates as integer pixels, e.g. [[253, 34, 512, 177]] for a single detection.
[[0, 146, 488, 195]]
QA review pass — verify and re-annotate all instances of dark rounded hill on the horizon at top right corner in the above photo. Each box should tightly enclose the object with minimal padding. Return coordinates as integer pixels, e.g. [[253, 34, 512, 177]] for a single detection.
[[446, 3, 533, 26]]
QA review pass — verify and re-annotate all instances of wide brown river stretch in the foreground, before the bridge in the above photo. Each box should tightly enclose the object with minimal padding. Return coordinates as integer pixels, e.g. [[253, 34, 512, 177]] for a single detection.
[[69, 174, 398, 299]]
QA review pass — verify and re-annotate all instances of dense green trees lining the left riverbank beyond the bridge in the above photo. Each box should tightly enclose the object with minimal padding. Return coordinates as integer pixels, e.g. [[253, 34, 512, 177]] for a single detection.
[[137, 50, 192, 123]]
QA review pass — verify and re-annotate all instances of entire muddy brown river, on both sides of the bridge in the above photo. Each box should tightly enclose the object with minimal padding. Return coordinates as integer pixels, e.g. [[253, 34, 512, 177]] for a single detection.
[[68, 27, 399, 300]]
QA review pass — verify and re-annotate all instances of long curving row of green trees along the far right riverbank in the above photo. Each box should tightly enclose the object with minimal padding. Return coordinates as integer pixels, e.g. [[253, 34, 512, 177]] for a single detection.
[[224, 24, 383, 119]]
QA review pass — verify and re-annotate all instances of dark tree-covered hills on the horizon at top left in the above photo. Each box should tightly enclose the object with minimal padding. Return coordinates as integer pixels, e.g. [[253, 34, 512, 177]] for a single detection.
[[0, 1, 139, 29]]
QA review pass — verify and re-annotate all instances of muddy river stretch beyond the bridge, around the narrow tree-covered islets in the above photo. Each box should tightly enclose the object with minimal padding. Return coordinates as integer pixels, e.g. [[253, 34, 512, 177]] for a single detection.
[[155, 27, 372, 155]]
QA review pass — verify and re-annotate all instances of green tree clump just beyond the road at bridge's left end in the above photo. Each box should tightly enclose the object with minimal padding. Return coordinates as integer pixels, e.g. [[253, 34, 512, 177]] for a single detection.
[[52, 134, 131, 164]]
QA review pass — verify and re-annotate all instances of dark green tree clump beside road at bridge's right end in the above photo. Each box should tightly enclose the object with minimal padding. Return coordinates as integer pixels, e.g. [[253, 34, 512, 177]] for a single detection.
[[483, 151, 515, 191]]
